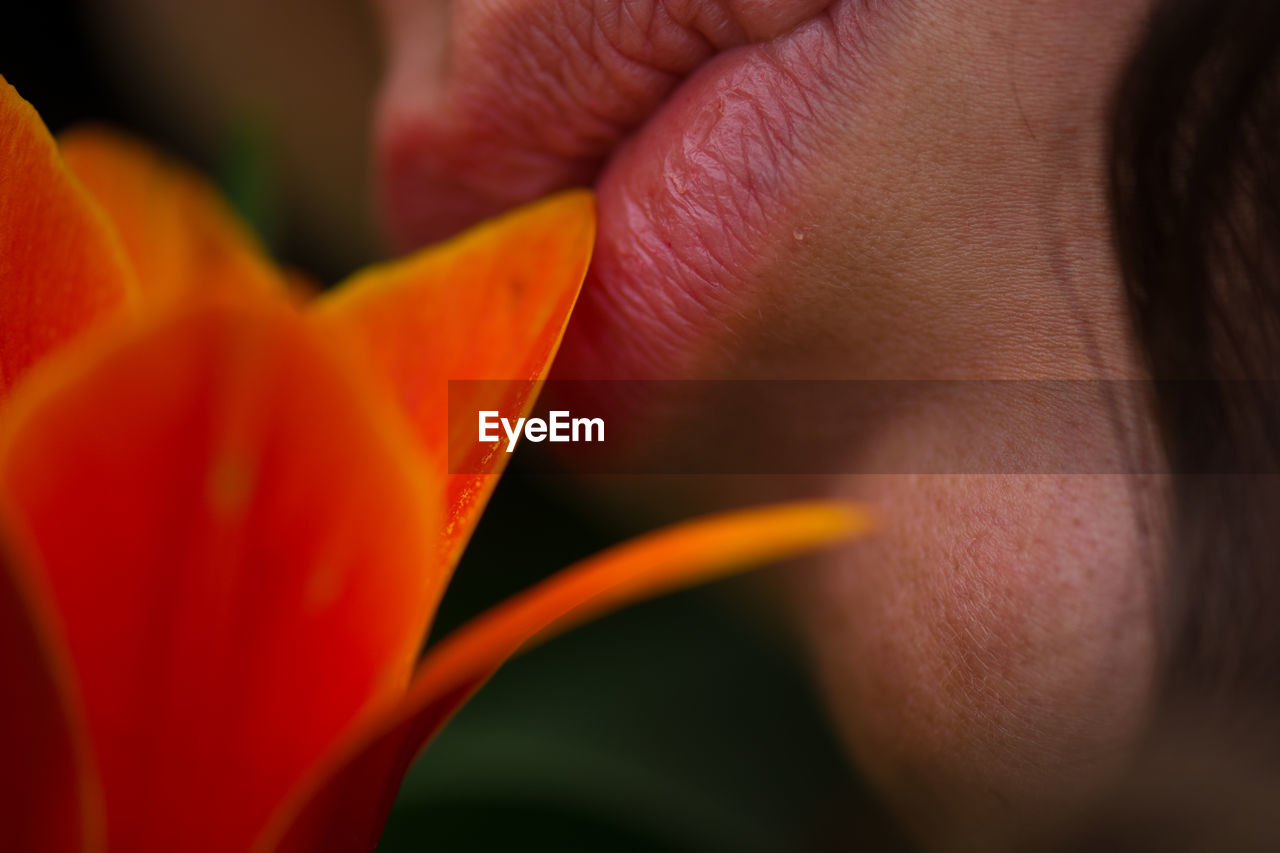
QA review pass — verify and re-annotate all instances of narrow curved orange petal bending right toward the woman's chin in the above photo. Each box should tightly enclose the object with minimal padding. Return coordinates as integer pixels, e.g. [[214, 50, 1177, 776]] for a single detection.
[[255, 503, 870, 853]]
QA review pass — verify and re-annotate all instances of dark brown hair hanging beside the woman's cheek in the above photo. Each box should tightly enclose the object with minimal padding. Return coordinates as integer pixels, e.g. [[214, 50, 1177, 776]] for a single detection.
[[1074, 0, 1280, 850]]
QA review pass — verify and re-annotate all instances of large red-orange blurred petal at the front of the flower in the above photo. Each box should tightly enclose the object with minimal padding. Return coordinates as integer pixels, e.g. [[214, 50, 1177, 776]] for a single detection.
[[0, 294, 438, 853]]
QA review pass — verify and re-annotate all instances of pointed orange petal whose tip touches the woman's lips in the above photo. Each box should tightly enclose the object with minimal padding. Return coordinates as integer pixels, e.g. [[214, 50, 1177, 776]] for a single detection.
[[312, 191, 595, 578]]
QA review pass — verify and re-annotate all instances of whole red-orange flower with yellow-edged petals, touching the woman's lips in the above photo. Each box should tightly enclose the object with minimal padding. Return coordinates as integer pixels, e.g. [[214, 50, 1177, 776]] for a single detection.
[[0, 81, 865, 853]]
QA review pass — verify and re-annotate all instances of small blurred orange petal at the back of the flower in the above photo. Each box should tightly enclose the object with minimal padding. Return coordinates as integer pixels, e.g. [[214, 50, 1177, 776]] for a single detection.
[[59, 127, 284, 304]]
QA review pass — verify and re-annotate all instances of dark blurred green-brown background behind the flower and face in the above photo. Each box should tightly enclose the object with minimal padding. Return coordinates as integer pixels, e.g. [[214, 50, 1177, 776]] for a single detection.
[[0, 0, 904, 853]]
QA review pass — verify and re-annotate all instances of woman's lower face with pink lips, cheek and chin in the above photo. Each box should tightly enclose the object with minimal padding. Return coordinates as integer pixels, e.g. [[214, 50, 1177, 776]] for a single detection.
[[379, 0, 1160, 844]]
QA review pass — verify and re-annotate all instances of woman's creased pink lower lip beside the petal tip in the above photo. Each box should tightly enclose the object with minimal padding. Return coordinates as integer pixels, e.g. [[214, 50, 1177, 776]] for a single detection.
[[547, 47, 803, 379]]
